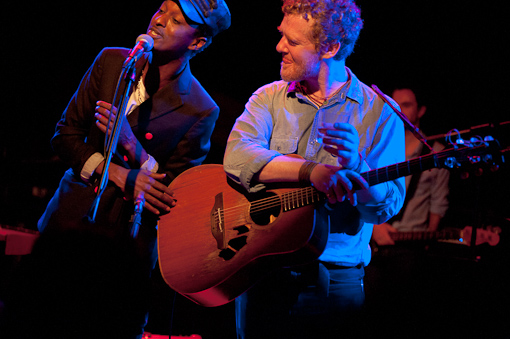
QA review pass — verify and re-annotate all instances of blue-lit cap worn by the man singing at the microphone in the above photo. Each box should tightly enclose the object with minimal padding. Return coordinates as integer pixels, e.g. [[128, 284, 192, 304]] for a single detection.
[[178, 0, 230, 36]]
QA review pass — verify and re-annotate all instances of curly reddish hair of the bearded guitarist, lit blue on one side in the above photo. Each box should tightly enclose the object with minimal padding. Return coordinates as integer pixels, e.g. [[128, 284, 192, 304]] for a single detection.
[[282, 0, 363, 60]]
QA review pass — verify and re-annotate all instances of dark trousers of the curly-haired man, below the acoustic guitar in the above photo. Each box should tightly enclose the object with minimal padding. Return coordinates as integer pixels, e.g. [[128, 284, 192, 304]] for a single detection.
[[235, 262, 365, 339]]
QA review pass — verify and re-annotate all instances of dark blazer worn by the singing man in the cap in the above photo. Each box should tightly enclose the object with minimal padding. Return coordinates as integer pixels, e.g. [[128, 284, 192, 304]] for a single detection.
[[38, 48, 219, 250]]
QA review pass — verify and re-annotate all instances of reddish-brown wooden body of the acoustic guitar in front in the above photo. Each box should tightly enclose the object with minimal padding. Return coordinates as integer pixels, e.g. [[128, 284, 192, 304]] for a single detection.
[[158, 165, 328, 306]]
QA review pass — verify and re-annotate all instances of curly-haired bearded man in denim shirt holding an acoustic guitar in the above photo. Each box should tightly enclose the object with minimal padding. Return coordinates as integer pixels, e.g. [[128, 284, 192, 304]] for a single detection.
[[224, 0, 405, 339]]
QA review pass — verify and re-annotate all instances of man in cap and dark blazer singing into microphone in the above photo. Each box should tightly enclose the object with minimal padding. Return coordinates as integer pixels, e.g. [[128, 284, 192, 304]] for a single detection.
[[28, 0, 230, 338]]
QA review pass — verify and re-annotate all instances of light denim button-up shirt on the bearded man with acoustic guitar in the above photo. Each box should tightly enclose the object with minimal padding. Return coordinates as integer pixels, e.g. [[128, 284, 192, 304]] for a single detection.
[[224, 68, 405, 266]]
